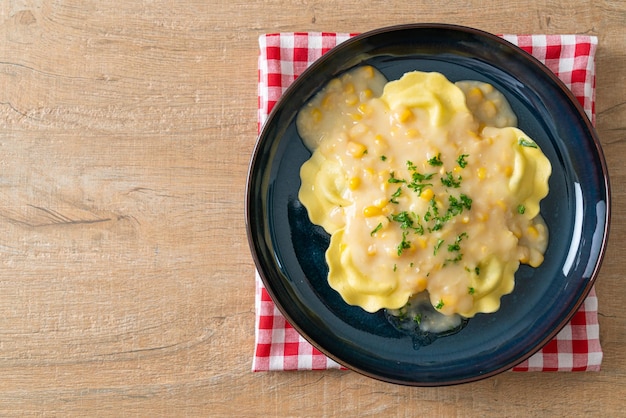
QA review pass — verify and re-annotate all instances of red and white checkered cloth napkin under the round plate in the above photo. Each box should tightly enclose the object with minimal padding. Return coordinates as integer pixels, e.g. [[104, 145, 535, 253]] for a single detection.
[[252, 32, 602, 371]]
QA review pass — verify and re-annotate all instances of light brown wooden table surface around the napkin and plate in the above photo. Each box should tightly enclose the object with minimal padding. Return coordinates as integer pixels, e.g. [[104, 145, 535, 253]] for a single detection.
[[0, 0, 626, 417]]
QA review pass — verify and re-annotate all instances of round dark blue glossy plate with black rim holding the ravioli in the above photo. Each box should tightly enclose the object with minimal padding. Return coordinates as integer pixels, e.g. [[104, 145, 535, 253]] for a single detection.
[[246, 24, 610, 386]]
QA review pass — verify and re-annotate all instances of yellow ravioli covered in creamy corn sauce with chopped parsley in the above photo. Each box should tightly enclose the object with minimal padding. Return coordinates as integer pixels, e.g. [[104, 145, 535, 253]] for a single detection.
[[297, 66, 551, 318]]
